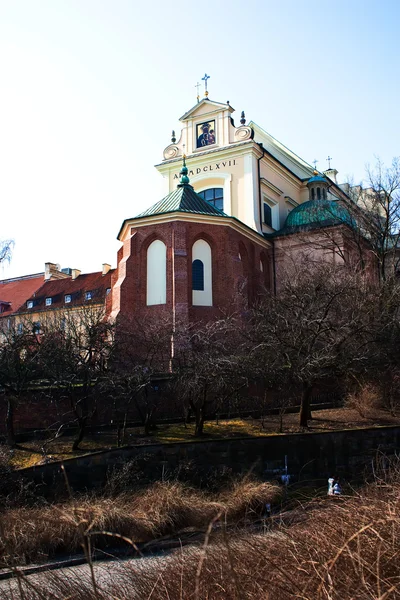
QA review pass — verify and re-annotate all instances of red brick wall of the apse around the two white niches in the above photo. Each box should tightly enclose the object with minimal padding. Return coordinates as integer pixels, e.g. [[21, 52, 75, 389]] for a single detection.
[[112, 221, 271, 321]]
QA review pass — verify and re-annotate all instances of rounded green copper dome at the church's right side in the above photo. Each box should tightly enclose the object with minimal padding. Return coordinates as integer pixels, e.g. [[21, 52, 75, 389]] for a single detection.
[[283, 200, 354, 233]]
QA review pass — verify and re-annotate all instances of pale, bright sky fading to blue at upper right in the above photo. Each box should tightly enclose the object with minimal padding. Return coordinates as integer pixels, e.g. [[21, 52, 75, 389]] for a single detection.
[[0, 0, 400, 277]]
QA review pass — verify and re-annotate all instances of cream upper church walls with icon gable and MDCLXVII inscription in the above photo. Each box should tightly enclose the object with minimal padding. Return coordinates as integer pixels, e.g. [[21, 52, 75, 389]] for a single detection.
[[156, 99, 343, 238]]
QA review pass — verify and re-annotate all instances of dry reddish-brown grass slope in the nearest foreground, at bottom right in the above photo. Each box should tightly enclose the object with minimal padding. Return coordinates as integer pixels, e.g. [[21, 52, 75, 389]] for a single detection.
[[0, 473, 400, 600]]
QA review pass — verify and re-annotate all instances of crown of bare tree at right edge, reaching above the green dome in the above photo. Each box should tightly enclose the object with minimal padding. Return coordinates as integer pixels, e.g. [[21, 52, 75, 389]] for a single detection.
[[301, 158, 400, 281]]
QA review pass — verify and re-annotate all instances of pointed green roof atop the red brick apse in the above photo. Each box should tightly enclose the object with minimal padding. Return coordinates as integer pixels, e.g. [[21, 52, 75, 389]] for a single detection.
[[135, 183, 228, 219]]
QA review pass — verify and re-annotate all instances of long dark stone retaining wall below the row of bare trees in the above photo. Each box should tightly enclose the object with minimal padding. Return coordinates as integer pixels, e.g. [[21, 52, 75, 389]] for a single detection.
[[20, 426, 400, 495]]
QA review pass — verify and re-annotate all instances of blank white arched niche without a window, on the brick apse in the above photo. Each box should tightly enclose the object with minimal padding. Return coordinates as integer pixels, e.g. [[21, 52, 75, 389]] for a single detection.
[[146, 240, 167, 306]]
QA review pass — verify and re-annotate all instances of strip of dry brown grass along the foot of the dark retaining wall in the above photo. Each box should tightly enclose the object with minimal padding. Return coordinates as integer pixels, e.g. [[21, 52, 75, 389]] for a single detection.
[[0, 479, 280, 566]]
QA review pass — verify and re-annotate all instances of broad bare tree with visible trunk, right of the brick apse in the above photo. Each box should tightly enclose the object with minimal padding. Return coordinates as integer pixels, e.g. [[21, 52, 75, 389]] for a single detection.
[[249, 264, 375, 427]]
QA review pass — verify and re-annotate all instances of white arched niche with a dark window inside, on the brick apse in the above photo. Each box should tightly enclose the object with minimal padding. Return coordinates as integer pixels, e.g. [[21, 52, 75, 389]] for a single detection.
[[192, 240, 213, 306]]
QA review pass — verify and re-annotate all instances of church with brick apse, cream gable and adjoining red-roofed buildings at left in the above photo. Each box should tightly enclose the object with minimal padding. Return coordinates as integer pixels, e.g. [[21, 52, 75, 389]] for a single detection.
[[0, 92, 360, 323]]
